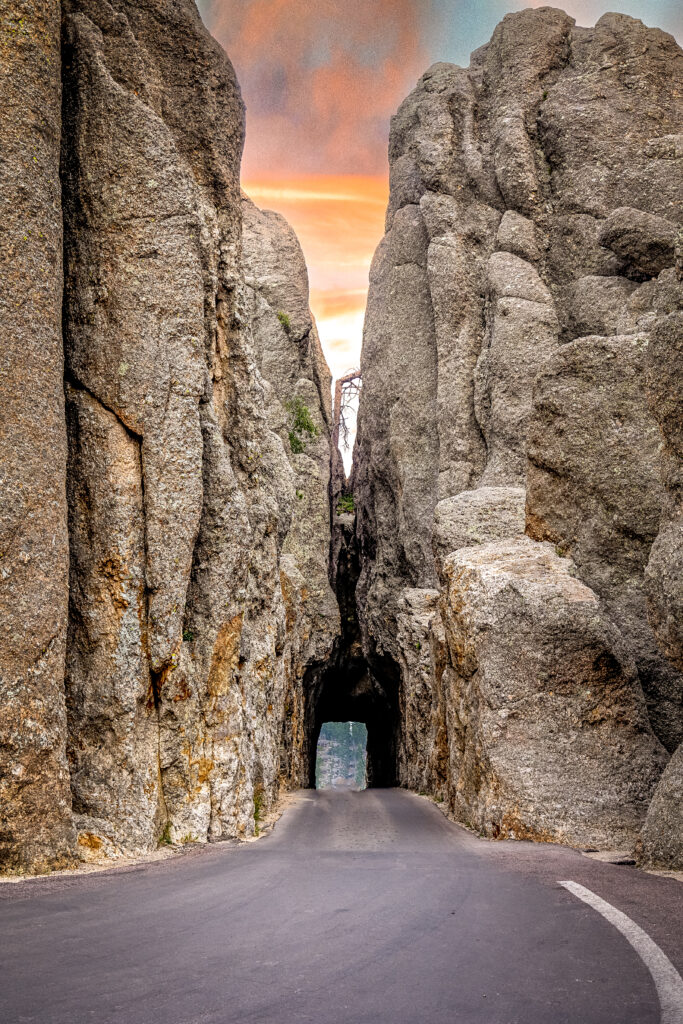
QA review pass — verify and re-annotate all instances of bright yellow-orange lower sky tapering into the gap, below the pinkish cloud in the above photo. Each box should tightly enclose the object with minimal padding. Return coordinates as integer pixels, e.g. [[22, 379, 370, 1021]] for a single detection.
[[243, 174, 388, 377]]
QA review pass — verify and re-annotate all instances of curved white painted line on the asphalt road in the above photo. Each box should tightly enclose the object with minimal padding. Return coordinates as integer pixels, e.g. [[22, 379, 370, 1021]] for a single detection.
[[558, 882, 683, 1024]]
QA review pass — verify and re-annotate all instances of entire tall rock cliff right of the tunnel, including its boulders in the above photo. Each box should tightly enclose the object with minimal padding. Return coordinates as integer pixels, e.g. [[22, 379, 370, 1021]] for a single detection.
[[353, 7, 683, 862]]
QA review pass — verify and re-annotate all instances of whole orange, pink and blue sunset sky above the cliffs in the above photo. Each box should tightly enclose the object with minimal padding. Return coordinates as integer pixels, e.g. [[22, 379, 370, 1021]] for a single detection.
[[199, 0, 683, 387]]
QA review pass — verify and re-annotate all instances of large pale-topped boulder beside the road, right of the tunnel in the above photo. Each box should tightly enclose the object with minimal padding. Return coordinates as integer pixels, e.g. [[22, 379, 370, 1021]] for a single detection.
[[442, 538, 667, 847]]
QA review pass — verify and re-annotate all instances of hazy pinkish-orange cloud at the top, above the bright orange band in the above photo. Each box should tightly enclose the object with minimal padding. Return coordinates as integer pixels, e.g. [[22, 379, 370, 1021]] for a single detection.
[[204, 0, 432, 177]]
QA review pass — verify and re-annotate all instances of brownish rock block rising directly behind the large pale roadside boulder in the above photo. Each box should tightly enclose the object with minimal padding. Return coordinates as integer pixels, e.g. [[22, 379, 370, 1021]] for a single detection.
[[527, 335, 683, 751]]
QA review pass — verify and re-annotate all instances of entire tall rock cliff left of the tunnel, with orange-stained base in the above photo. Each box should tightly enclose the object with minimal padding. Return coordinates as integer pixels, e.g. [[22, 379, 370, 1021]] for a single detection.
[[0, 0, 339, 870]]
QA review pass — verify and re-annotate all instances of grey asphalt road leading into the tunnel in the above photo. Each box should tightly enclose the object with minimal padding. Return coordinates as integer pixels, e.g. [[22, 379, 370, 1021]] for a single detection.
[[0, 790, 683, 1024]]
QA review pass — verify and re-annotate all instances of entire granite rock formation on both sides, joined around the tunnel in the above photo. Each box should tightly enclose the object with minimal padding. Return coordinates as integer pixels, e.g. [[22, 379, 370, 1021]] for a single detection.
[[0, 0, 683, 871]]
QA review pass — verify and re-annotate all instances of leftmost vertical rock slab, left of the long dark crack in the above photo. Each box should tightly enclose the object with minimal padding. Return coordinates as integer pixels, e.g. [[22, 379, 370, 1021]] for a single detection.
[[0, 0, 75, 870]]
